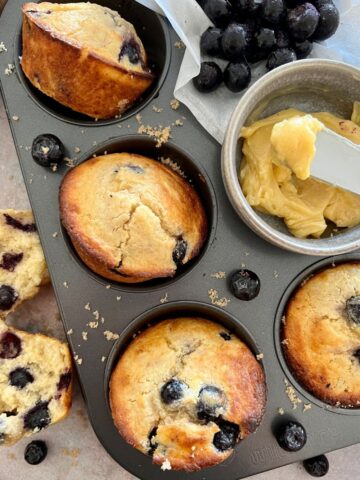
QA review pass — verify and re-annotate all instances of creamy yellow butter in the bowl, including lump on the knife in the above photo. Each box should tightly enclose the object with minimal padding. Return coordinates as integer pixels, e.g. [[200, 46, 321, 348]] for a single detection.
[[239, 108, 360, 238]]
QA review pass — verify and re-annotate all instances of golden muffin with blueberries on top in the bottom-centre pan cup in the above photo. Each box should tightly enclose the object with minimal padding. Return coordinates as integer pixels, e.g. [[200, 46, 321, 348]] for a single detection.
[[110, 318, 266, 471]]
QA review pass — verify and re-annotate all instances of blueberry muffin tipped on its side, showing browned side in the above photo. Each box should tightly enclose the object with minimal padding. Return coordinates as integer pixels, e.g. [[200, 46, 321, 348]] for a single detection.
[[21, 2, 154, 119]]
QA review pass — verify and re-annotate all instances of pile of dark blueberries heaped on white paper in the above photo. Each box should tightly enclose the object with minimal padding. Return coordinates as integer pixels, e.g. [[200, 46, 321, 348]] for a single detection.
[[193, 0, 340, 93]]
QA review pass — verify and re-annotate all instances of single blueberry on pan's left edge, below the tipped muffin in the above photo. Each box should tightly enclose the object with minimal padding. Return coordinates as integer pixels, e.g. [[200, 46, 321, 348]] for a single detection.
[[31, 133, 65, 167]]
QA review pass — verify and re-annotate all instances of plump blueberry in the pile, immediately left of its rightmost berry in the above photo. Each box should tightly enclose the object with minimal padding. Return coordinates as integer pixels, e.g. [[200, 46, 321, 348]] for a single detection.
[[286, 3, 319, 42]]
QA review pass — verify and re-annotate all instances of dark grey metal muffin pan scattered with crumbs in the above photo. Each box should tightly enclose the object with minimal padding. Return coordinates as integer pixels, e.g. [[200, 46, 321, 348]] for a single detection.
[[0, 0, 360, 480]]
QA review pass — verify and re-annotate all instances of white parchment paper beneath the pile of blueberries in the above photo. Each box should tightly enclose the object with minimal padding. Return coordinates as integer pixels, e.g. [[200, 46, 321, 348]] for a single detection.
[[138, 0, 360, 143]]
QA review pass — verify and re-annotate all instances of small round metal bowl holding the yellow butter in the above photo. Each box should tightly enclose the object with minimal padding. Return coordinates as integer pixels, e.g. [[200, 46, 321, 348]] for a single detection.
[[222, 59, 360, 256]]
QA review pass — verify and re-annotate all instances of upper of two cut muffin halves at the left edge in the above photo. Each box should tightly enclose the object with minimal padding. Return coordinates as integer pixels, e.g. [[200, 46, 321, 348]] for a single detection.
[[0, 210, 49, 319]]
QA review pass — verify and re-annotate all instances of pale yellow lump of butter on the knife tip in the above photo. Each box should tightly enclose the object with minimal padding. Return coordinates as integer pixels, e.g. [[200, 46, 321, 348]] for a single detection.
[[270, 115, 324, 180]]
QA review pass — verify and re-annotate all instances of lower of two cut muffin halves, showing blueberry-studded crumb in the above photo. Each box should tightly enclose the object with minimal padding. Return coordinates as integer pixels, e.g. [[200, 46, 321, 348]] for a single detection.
[[0, 322, 72, 444]]
